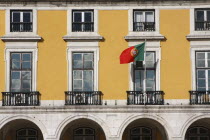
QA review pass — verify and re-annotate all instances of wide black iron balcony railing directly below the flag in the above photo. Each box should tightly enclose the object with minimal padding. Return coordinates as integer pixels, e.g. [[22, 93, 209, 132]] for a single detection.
[[127, 91, 164, 105]]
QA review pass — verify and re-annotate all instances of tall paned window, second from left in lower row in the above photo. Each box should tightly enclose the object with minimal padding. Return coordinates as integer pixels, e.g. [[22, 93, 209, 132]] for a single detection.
[[72, 52, 94, 91]]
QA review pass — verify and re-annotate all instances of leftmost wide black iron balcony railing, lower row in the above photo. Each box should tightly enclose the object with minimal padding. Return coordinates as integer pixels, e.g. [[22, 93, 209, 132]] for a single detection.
[[2, 91, 40, 106]]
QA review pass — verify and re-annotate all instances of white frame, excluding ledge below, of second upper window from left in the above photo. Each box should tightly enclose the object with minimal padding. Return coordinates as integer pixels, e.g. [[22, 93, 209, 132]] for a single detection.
[[67, 7, 98, 37]]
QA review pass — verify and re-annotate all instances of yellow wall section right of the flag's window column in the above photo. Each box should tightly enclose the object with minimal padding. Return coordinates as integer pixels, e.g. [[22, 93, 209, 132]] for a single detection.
[[160, 10, 191, 99]]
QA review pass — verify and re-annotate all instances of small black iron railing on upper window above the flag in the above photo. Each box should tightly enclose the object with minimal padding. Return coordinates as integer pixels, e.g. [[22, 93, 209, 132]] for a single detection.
[[133, 22, 155, 31]]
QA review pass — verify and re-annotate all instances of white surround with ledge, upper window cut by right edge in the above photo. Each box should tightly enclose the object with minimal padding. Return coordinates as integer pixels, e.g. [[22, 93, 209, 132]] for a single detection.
[[186, 7, 210, 40]]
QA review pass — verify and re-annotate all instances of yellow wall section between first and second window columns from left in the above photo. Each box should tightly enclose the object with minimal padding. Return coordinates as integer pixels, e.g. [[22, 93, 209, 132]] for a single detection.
[[37, 10, 67, 100]]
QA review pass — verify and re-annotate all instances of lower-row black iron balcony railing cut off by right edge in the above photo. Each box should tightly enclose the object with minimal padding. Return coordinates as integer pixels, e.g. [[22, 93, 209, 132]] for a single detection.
[[189, 91, 210, 105]]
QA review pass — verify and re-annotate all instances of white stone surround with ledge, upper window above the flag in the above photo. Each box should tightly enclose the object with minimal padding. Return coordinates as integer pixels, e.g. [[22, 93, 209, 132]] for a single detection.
[[125, 7, 164, 40]]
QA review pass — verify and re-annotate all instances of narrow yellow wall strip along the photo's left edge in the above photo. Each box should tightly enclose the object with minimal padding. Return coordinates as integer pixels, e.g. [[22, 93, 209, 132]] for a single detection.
[[0, 10, 6, 100]]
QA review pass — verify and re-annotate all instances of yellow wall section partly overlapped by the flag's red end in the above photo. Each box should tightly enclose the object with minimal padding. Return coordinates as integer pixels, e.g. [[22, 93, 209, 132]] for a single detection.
[[98, 10, 129, 99]]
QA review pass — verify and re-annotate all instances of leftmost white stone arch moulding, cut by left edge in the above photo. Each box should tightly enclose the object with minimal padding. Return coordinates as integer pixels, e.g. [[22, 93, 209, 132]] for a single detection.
[[0, 115, 48, 140]]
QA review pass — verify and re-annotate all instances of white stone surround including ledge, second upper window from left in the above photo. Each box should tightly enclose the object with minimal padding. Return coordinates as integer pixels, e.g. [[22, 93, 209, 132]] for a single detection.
[[63, 7, 102, 40]]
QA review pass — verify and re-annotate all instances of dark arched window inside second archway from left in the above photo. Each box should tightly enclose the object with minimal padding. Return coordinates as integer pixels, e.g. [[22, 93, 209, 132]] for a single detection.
[[74, 127, 95, 140]]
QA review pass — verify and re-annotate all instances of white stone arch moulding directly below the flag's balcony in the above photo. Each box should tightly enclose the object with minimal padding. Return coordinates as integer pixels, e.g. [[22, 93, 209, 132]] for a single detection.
[[117, 114, 173, 140]]
